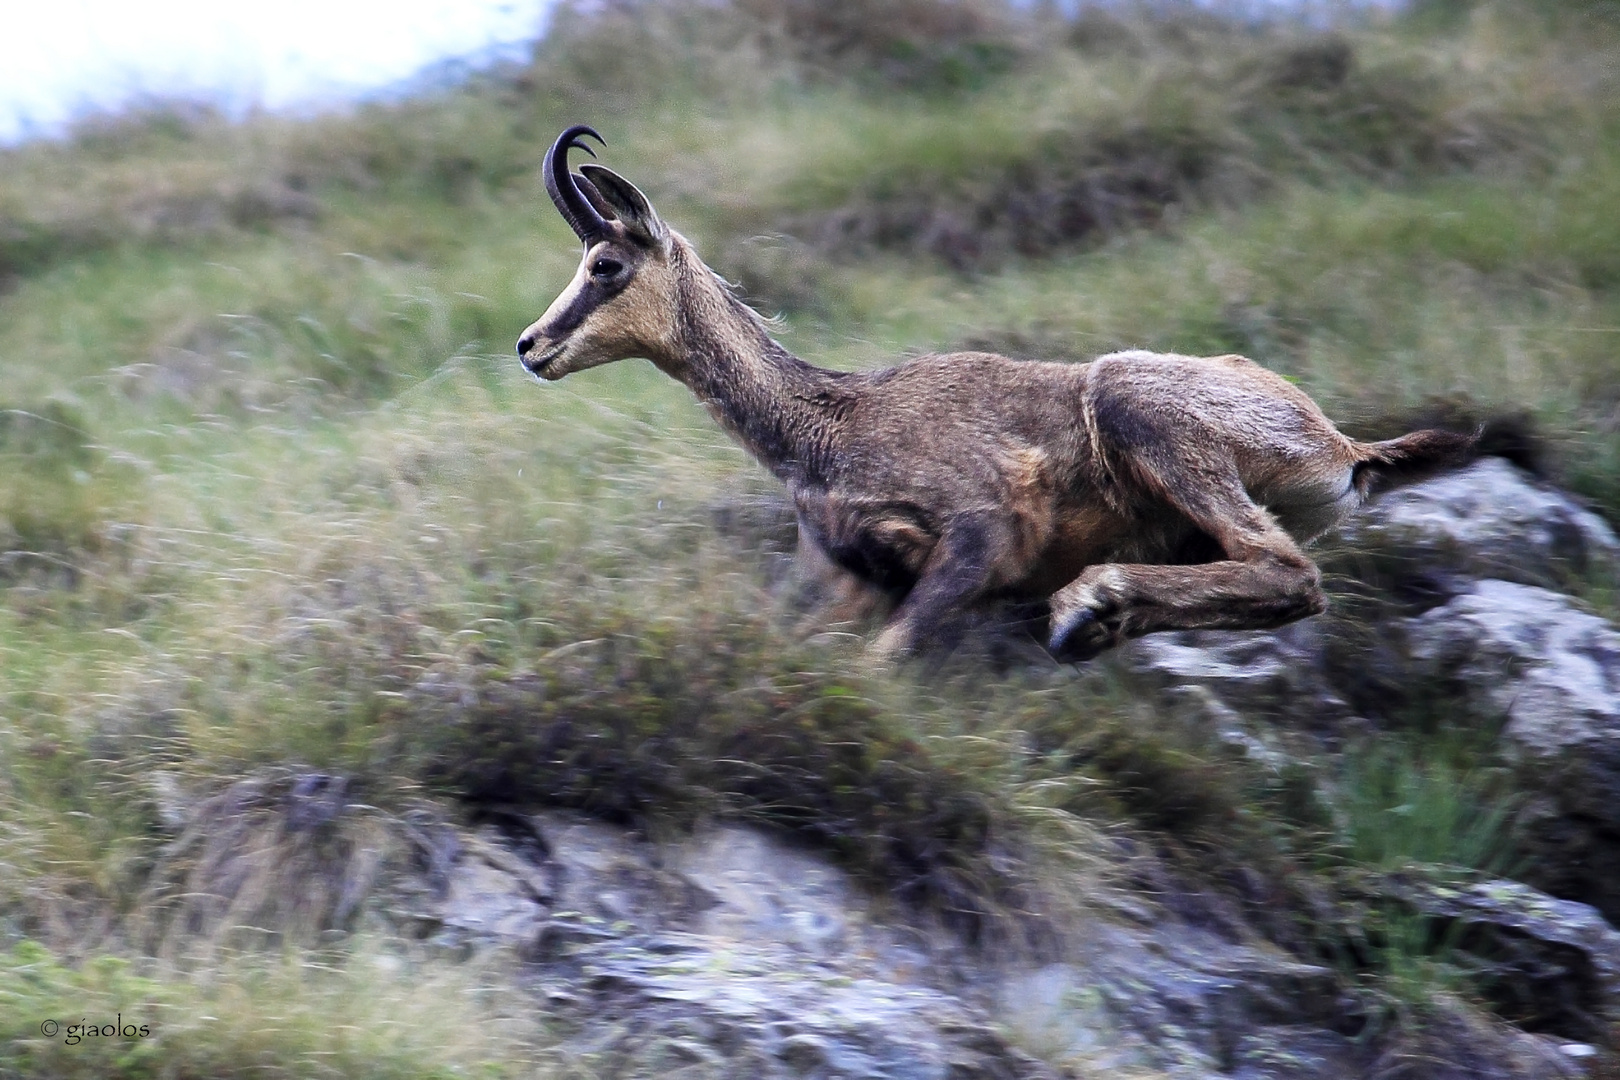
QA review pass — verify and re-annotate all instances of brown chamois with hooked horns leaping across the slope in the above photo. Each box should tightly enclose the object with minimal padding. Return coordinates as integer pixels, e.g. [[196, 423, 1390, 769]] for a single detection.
[[517, 125, 1476, 661]]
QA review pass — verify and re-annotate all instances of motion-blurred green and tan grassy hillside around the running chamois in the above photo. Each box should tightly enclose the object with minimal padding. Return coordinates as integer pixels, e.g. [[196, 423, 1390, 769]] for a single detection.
[[0, 0, 1620, 1077]]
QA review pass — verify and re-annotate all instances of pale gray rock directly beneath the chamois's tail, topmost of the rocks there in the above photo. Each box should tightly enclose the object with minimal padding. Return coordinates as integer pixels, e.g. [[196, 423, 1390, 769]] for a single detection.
[[1341, 458, 1620, 585]]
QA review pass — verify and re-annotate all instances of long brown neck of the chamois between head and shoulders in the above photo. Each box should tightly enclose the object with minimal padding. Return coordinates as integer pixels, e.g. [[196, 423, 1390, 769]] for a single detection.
[[659, 256, 852, 481]]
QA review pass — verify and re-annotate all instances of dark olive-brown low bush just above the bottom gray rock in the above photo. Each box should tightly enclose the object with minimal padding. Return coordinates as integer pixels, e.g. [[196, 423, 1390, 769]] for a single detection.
[[395, 621, 1016, 926]]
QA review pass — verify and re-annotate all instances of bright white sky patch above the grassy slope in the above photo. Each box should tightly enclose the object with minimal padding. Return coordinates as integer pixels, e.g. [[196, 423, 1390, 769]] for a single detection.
[[0, 0, 551, 142]]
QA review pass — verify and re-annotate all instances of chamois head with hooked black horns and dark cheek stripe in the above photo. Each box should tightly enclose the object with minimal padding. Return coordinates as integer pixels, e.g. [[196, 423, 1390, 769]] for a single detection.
[[517, 125, 677, 379]]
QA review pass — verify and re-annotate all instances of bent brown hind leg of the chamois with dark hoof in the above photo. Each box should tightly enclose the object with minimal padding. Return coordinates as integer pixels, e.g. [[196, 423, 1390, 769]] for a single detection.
[[1048, 468, 1327, 661]]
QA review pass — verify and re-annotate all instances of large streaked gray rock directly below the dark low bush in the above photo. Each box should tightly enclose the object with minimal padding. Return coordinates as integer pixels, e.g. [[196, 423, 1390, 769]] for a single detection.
[[395, 813, 1053, 1080]]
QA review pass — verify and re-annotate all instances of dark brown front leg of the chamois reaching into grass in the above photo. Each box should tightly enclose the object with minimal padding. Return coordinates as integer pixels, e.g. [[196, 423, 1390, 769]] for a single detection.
[[868, 515, 1009, 664]]
